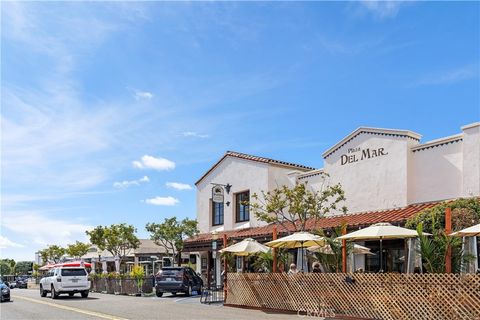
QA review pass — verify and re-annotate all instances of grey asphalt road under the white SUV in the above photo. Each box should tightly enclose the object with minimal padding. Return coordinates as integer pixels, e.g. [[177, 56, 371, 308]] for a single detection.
[[0, 289, 297, 320]]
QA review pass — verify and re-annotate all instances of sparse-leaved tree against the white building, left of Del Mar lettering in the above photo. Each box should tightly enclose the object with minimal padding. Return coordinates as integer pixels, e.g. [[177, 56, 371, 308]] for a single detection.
[[250, 180, 347, 232]]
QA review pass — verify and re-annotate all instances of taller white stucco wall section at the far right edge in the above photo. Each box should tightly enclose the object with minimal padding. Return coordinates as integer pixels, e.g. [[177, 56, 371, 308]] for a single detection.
[[462, 122, 480, 197]]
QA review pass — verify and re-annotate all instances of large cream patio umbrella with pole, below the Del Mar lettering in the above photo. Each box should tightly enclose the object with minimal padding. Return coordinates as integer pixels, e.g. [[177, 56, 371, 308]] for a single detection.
[[337, 223, 430, 272]]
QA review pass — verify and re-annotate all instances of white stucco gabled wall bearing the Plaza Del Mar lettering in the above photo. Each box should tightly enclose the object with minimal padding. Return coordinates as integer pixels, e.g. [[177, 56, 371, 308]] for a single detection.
[[316, 133, 415, 213]]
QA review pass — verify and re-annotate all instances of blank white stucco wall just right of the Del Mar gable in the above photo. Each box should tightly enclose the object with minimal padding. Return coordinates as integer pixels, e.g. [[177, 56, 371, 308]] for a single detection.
[[410, 141, 463, 203]]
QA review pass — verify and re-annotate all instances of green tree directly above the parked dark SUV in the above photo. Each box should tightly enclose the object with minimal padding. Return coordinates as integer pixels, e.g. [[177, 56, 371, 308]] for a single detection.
[[145, 217, 198, 264]]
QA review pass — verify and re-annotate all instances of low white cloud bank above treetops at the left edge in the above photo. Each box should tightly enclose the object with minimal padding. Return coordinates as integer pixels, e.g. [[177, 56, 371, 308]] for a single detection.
[[2, 211, 93, 250]]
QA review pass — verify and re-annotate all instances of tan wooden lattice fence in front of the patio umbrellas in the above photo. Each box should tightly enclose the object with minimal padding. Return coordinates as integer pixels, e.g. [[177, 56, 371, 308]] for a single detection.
[[226, 273, 480, 320]]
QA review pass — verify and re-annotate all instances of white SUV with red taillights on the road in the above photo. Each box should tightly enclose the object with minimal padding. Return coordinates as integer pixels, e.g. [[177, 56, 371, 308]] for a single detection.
[[40, 267, 90, 299]]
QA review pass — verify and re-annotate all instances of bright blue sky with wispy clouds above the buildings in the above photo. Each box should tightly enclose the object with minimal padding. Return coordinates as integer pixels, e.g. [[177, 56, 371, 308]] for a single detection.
[[0, 2, 480, 259]]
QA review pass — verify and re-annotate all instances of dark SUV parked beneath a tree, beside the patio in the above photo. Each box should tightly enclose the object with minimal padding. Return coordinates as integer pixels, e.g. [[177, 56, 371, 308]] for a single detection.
[[155, 267, 203, 297]]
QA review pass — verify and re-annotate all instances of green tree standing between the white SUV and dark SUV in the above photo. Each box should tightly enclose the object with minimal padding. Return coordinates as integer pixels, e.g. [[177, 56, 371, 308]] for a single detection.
[[86, 223, 140, 271]]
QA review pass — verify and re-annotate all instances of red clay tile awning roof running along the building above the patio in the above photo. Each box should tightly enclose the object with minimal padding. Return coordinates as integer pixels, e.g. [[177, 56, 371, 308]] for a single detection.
[[185, 201, 442, 248]]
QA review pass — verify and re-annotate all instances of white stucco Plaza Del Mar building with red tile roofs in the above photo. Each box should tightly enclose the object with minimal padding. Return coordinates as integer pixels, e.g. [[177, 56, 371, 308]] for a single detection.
[[185, 123, 480, 282]]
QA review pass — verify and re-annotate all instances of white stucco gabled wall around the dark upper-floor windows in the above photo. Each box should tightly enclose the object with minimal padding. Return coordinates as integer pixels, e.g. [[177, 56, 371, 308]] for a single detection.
[[197, 157, 269, 233]]
